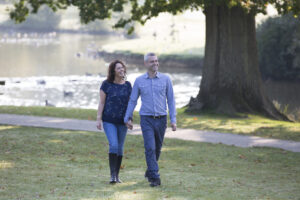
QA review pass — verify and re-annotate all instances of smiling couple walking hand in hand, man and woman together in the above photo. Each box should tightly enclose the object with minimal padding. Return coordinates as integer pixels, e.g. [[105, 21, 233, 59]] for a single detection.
[[97, 53, 176, 187]]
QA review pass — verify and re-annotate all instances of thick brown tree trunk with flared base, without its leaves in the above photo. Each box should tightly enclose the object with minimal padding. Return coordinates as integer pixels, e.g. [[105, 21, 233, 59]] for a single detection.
[[188, 2, 287, 120]]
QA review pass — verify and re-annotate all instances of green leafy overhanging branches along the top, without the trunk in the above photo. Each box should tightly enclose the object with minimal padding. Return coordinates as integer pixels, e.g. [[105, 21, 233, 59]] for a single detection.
[[10, 0, 300, 33]]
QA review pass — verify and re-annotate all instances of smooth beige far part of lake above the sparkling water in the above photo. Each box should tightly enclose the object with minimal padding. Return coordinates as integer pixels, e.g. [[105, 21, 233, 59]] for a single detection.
[[0, 33, 113, 77]]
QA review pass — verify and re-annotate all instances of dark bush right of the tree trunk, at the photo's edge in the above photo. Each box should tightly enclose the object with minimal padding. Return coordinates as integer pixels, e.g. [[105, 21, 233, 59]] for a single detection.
[[257, 13, 300, 80]]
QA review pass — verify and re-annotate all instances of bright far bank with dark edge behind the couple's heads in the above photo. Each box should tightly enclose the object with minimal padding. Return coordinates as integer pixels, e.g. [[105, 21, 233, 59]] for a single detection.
[[98, 32, 204, 69]]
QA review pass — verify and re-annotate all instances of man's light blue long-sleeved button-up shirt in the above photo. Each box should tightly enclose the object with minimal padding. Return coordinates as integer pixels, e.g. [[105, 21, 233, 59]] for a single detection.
[[124, 72, 176, 123]]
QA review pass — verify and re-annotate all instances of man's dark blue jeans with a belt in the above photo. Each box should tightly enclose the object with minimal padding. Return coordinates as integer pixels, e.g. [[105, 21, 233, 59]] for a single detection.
[[141, 115, 167, 178]]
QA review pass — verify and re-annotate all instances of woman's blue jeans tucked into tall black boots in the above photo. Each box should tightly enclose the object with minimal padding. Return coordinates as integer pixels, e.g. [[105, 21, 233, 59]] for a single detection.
[[103, 122, 127, 156]]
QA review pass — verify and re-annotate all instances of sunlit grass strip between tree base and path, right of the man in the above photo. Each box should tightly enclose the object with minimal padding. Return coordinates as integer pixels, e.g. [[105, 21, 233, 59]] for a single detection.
[[177, 108, 300, 141]]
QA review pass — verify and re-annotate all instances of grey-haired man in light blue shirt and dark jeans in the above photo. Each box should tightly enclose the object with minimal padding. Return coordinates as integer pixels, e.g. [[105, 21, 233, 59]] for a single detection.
[[124, 53, 176, 187]]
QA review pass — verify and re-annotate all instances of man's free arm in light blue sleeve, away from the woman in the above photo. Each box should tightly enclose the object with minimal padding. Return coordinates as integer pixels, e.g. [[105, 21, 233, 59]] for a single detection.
[[167, 77, 176, 131]]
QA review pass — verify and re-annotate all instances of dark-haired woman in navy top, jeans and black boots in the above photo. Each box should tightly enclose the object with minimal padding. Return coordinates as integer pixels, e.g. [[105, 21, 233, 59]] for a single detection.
[[97, 60, 132, 183]]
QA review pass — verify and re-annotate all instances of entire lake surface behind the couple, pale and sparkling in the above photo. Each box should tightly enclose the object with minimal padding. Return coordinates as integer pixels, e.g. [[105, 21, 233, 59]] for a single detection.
[[0, 32, 201, 109]]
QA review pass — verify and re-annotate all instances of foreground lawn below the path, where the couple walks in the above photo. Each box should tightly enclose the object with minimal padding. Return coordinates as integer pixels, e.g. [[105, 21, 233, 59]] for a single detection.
[[0, 125, 300, 200]]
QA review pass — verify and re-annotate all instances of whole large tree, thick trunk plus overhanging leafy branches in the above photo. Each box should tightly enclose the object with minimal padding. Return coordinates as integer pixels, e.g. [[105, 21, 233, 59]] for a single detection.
[[10, 0, 300, 119]]
